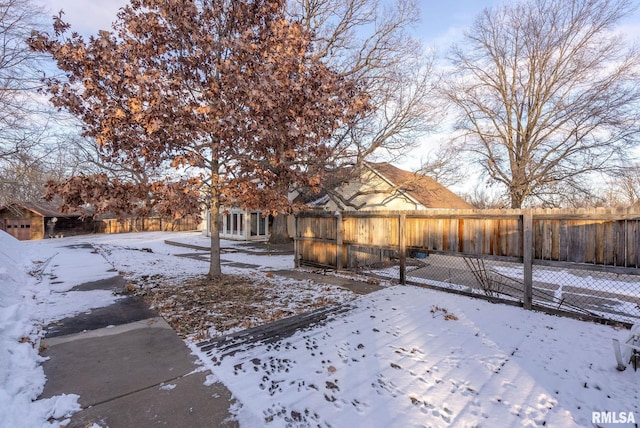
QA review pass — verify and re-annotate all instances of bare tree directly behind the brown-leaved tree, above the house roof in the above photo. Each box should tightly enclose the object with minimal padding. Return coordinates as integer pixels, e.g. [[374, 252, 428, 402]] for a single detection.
[[270, 0, 441, 242]]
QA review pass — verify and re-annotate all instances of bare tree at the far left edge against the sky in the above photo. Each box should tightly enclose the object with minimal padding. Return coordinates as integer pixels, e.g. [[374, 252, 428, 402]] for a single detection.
[[0, 0, 75, 205]]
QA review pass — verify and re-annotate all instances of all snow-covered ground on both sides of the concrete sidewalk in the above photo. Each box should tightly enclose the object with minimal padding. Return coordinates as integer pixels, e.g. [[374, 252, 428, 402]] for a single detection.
[[0, 232, 640, 427]]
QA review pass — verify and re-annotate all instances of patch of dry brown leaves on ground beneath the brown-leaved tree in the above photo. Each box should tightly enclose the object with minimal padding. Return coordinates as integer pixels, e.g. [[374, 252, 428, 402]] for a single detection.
[[126, 275, 352, 341]]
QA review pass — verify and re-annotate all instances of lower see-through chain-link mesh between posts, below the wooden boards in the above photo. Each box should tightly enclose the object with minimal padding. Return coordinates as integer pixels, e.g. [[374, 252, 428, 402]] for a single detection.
[[345, 246, 640, 324]]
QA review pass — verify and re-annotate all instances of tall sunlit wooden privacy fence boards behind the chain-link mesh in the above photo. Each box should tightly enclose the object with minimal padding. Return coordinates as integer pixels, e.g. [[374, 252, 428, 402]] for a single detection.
[[295, 208, 640, 318]]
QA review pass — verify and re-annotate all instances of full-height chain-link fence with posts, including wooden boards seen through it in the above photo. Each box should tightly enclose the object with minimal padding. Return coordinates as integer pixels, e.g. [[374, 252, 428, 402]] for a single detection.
[[296, 207, 640, 324]]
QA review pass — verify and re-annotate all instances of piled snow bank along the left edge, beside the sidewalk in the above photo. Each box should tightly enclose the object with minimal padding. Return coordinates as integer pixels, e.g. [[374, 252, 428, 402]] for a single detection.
[[0, 231, 80, 427]]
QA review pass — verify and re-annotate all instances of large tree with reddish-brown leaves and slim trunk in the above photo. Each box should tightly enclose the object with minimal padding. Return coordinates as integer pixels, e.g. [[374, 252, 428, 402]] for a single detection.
[[29, 0, 367, 276]]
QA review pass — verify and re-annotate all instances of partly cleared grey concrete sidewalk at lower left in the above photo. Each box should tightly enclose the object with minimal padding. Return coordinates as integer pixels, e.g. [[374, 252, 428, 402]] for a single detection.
[[41, 244, 238, 428]]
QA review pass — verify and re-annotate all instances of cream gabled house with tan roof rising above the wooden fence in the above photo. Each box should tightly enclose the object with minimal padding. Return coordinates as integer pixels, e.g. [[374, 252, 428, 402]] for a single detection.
[[309, 162, 473, 211]]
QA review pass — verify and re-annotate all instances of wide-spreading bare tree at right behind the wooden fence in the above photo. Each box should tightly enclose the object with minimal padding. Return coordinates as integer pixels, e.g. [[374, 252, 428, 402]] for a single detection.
[[445, 0, 640, 208]]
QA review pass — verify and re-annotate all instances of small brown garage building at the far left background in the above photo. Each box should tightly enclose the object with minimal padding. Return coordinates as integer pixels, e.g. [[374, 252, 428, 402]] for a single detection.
[[0, 202, 93, 240]]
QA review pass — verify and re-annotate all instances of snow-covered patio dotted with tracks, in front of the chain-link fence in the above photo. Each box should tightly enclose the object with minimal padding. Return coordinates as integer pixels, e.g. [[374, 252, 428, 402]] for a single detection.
[[196, 287, 640, 427]]
